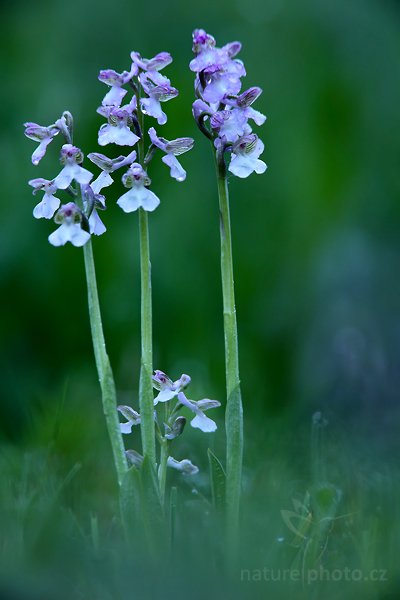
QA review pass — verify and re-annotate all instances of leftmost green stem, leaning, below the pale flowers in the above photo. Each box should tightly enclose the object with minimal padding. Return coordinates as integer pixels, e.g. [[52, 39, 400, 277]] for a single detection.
[[83, 240, 128, 486]]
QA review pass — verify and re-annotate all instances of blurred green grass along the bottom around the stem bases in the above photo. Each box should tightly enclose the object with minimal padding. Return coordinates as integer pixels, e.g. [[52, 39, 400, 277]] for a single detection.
[[0, 410, 400, 600]]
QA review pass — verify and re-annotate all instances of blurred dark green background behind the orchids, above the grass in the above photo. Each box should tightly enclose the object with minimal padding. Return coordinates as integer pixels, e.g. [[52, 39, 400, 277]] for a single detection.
[[0, 0, 400, 596]]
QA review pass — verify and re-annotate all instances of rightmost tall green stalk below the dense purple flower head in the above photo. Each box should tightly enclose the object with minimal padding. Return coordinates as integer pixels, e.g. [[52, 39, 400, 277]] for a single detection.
[[216, 155, 243, 555]]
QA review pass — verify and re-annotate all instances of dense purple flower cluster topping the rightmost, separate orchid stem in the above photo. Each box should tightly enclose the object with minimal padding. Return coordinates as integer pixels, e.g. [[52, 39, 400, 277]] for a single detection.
[[190, 29, 267, 178]]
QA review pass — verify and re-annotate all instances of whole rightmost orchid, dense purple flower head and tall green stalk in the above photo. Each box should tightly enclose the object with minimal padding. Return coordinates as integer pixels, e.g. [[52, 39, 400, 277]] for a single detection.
[[190, 29, 267, 552]]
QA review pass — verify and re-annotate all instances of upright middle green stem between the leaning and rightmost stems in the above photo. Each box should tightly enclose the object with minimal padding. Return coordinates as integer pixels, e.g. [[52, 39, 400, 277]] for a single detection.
[[139, 208, 156, 467]]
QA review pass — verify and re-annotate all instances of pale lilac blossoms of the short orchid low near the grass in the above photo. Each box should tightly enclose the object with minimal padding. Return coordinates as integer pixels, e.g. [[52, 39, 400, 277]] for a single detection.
[[118, 370, 221, 475]]
